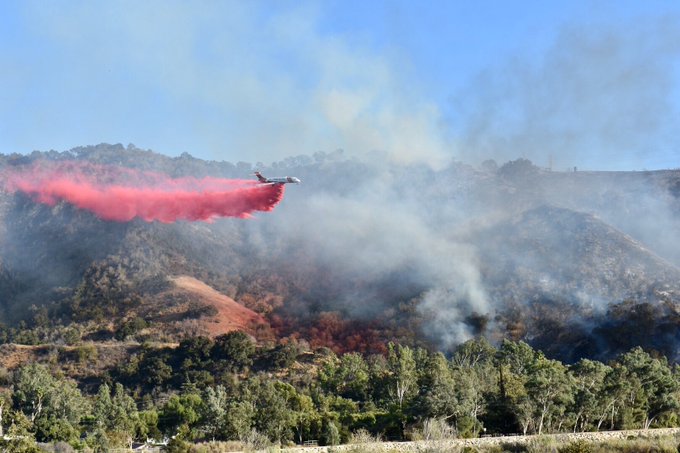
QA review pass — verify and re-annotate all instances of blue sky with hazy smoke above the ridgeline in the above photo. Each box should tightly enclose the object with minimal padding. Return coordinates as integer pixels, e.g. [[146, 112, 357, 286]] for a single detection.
[[0, 0, 680, 169]]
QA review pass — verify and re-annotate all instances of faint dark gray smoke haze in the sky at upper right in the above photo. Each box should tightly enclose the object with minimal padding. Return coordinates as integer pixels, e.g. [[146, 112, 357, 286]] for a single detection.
[[449, 15, 680, 170]]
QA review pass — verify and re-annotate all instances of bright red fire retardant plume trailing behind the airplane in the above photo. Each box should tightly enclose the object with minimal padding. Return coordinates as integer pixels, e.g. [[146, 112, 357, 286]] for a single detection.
[[0, 161, 284, 223]]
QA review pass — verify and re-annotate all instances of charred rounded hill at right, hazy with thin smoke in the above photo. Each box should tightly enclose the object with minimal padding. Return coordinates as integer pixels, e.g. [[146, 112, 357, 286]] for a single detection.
[[479, 205, 680, 361]]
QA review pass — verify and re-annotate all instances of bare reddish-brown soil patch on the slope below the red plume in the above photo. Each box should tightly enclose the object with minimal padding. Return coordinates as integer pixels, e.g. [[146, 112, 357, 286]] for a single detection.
[[170, 275, 268, 337]]
